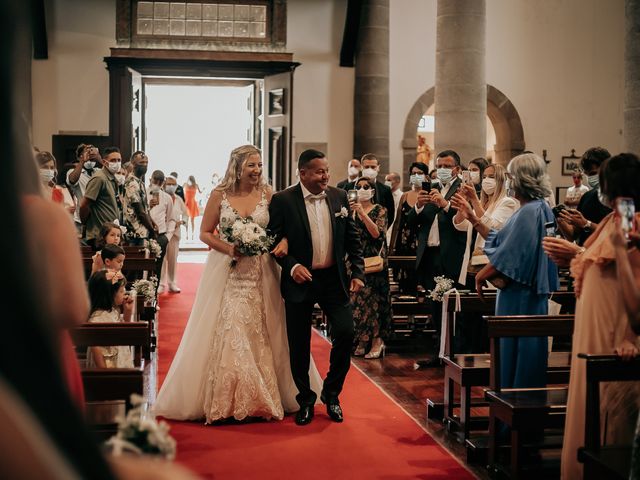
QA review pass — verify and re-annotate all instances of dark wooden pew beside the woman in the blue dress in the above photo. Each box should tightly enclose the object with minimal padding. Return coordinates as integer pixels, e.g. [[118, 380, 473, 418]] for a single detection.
[[485, 315, 574, 478]]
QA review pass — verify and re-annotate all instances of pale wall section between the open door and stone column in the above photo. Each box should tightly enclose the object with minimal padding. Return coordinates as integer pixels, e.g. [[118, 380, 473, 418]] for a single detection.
[[287, 0, 354, 184]]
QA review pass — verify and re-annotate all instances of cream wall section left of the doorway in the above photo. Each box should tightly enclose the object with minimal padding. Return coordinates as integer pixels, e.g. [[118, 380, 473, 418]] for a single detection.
[[31, 0, 116, 150]]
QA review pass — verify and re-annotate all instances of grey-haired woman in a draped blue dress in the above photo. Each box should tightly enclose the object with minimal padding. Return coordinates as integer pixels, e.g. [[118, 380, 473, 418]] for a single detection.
[[476, 153, 558, 388]]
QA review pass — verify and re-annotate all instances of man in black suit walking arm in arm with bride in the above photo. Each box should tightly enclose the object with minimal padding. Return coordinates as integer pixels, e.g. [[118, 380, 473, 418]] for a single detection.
[[268, 150, 364, 425]]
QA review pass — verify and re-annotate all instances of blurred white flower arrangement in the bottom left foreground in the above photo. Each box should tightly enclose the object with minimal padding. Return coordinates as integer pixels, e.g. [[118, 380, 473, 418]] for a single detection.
[[106, 393, 176, 460]]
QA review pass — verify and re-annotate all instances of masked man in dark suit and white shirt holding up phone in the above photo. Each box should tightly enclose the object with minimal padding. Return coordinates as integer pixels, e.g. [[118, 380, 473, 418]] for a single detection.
[[407, 150, 467, 366]]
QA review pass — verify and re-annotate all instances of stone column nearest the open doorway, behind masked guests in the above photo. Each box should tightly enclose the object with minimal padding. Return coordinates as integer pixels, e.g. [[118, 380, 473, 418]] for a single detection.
[[356, 0, 389, 172]]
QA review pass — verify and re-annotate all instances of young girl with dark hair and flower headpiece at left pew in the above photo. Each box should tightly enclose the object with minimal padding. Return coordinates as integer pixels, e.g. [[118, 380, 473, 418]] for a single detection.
[[87, 270, 133, 368]]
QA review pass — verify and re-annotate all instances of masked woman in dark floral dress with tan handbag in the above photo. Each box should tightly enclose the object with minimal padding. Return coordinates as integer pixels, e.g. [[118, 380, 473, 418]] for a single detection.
[[350, 177, 391, 359]]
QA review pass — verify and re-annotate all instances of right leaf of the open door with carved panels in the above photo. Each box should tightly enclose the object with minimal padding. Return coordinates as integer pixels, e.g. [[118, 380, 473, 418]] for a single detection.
[[262, 69, 296, 190]]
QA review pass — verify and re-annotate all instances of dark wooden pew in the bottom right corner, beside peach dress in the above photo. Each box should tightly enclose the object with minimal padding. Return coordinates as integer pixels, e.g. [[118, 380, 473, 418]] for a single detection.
[[578, 353, 640, 480]]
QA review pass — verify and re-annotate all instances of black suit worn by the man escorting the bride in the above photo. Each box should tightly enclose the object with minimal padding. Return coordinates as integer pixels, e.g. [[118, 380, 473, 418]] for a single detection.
[[268, 184, 364, 406]]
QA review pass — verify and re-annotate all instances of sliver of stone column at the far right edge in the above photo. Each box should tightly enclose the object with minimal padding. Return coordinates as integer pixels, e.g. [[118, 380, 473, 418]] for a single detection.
[[624, 0, 640, 155]]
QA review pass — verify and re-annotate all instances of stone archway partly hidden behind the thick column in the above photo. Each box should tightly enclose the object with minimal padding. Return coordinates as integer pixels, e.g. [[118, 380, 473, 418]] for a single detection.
[[402, 85, 525, 184]]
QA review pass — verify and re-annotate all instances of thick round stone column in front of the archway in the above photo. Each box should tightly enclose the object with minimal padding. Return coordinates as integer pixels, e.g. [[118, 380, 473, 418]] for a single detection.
[[435, 0, 487, 164]]
